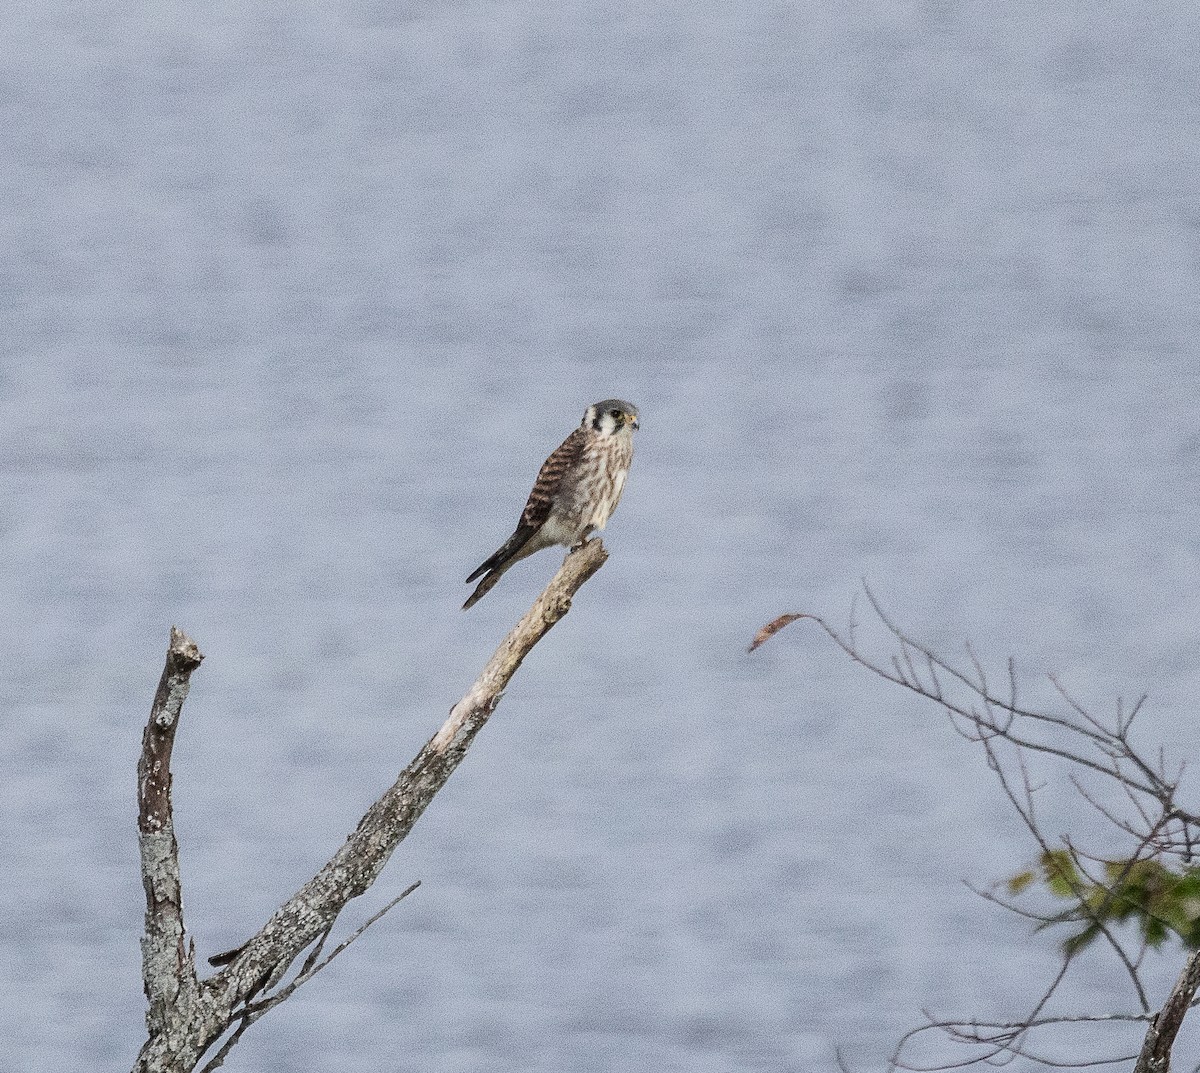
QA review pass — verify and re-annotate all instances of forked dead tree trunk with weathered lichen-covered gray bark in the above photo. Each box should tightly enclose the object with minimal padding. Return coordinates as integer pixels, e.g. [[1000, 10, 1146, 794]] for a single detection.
[[133, 540, 607, 1073]]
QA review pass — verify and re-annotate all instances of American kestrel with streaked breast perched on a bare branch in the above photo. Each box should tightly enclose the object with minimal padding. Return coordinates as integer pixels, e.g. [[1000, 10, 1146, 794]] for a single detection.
[[462, 398, 637, 611]]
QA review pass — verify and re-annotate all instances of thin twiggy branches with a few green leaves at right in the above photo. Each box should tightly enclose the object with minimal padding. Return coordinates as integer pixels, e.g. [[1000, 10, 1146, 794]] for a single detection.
[[750, 588, 1200, 1073]]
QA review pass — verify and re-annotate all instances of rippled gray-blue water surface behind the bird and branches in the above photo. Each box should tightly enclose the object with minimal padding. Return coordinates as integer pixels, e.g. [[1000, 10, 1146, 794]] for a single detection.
[[0, 0, 1200, 1073]]
